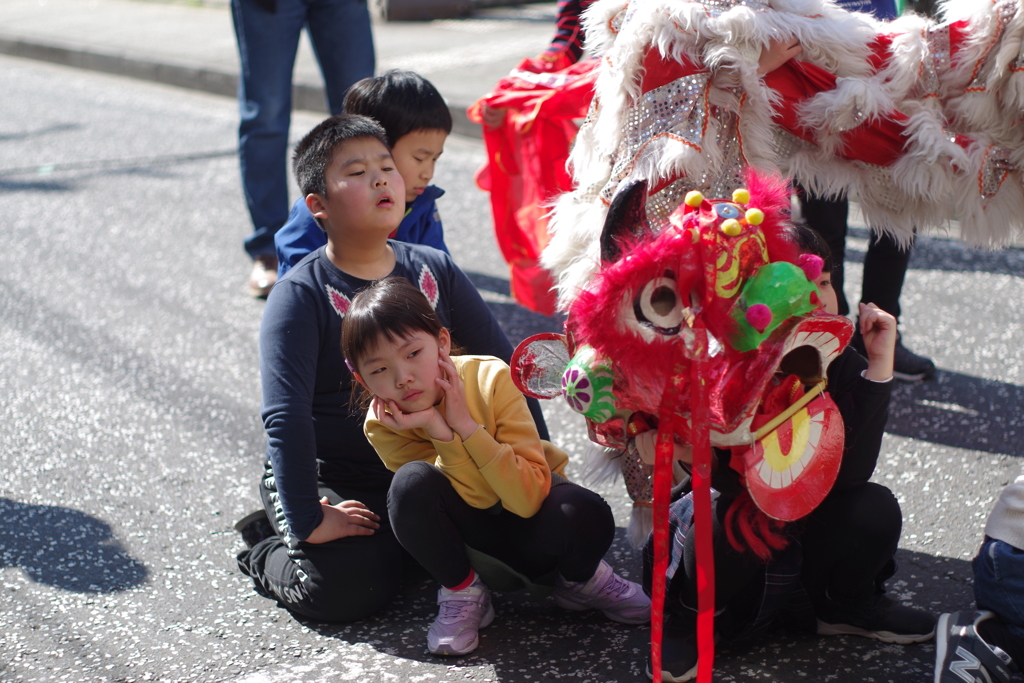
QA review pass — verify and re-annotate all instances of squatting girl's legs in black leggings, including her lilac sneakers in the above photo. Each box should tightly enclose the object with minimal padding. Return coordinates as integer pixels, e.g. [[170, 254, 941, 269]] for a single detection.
[[388, 462, 650, 654]]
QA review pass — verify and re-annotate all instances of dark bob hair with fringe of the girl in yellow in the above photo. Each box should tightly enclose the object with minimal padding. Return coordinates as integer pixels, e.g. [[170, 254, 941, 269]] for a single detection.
[[341, 278, 444, 374]]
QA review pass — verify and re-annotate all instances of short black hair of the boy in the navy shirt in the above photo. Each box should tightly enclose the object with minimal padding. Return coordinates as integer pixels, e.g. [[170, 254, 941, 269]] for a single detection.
[[292, 114, 391, 198]]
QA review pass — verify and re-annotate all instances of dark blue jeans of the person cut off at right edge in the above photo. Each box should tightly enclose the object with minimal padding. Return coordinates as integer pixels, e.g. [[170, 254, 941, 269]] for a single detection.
[[972, 539, 1024, 638]]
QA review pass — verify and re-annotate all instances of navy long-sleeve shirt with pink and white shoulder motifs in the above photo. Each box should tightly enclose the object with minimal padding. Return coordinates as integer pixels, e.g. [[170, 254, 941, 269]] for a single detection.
[[260, 241, 547, 540]]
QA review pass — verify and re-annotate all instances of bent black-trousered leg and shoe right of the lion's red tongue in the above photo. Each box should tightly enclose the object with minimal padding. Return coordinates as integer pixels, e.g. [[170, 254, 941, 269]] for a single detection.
[[801, 482, 935, 643]]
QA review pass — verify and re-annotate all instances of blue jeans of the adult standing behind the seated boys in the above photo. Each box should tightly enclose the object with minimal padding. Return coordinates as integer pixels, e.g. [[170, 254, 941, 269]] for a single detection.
[[231, 0, 374, 258]]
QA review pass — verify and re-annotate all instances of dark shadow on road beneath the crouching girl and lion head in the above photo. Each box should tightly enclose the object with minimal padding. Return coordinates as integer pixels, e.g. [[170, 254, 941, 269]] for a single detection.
[[288, 540, 973, 683]]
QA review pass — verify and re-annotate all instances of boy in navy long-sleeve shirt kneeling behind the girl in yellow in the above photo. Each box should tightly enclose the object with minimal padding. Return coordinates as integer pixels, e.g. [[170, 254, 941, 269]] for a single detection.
[[236, 114, 548, 622]]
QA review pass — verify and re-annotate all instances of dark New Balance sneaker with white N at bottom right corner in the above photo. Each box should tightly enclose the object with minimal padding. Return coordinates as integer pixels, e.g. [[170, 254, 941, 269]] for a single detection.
[[935, 611, 1013, 683]]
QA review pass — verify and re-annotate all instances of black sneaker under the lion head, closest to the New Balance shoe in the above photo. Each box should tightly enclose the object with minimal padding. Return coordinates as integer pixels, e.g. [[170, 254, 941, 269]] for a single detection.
[[815, 593, 935, 645]]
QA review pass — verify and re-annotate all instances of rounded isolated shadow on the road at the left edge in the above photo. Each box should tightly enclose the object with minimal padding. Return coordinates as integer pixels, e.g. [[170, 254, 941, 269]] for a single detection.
[[0, 498, 148, 593]]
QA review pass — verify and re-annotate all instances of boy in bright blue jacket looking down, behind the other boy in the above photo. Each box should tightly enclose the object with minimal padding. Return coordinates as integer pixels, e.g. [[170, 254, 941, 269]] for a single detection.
[[273, 70, 452, 280]]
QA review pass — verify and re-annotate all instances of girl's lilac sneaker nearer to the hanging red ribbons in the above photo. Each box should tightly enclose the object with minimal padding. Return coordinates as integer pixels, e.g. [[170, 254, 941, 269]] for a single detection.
[[555, 560, 650, 624]]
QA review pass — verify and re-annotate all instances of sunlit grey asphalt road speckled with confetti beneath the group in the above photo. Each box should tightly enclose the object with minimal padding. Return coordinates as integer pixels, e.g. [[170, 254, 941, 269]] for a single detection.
[[0, 57, 1024, 683]]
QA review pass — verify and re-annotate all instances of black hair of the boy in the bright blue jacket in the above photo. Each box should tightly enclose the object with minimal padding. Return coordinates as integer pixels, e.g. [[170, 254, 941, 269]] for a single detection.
[[342, 69, 452, 146]]
